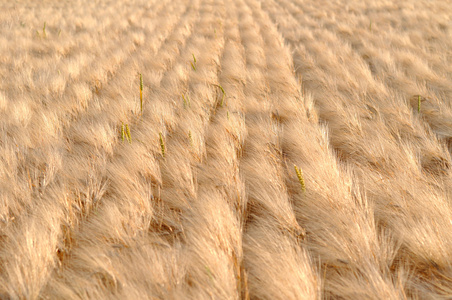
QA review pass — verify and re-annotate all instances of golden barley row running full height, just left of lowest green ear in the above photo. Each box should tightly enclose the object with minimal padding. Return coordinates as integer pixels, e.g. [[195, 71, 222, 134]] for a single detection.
[[237, 1, 320, 299]]
